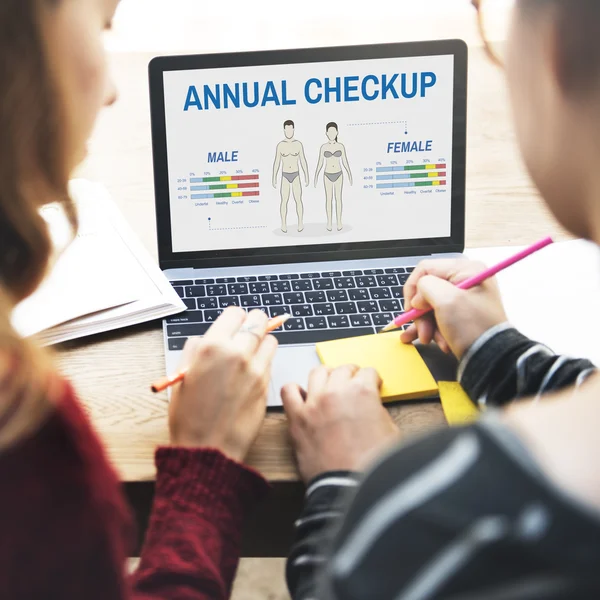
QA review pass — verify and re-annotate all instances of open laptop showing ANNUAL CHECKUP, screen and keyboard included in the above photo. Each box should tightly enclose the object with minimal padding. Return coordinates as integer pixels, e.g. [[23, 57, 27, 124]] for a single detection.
[[149, 40, 467, 406]]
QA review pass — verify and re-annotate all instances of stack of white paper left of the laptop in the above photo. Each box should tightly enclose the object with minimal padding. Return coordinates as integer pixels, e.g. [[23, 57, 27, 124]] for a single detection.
[[12, 180, 185, 345]]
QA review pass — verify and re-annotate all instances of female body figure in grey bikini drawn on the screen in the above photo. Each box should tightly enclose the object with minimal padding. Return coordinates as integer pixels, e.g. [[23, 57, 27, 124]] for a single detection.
[[315, 123, 352, 231]]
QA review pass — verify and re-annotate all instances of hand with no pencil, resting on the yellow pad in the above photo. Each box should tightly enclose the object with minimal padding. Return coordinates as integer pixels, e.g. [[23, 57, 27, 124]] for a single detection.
[[281, 366, 398, 482]]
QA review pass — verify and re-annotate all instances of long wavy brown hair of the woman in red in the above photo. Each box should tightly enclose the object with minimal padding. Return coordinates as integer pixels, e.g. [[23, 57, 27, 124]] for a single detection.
[[0, 0, 76, 448]]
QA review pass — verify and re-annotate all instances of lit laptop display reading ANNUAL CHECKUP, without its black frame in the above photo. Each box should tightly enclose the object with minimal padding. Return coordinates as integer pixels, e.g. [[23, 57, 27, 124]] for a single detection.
[[163, 55, 455, 253]]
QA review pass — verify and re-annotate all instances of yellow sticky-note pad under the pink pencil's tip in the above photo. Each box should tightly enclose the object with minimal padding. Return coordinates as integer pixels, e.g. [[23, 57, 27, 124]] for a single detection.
[[317, 333, 438, 402]]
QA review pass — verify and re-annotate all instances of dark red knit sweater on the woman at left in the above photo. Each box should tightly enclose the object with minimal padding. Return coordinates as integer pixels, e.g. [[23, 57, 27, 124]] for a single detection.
[[0, 386, 268, 600]]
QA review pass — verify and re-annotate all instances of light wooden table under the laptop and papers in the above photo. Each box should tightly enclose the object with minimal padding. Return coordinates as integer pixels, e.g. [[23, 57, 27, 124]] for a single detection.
[[57, 48, 567, 556]]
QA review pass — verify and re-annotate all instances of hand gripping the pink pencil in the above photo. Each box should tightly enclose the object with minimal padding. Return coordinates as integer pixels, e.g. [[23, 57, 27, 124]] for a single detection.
[[401, 259, 507, 359]]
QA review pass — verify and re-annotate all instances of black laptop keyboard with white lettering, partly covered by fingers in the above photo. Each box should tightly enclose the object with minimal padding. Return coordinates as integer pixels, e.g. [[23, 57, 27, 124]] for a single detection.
[[166, 267, 414, 350]]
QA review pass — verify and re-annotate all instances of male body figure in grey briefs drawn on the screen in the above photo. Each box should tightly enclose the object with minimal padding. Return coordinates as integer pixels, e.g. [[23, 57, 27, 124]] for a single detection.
[[273, 121, 310, 233]]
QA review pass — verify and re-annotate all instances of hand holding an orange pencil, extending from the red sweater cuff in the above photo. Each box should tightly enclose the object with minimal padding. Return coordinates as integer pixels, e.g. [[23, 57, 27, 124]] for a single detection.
[[169, 307, 277, 461]]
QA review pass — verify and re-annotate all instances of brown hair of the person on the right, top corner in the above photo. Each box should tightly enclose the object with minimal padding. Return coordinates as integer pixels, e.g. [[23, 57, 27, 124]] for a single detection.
[[518, 0, 600, 93]]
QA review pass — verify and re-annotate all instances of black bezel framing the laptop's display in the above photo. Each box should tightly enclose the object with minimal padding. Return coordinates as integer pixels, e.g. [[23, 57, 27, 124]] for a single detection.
[[148, 40, 468, 269]]
